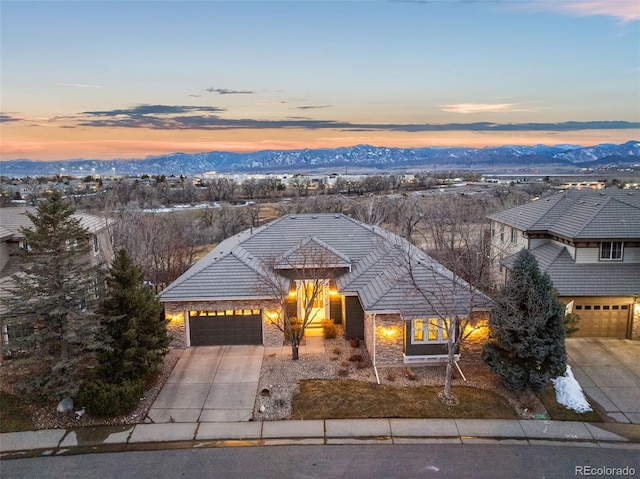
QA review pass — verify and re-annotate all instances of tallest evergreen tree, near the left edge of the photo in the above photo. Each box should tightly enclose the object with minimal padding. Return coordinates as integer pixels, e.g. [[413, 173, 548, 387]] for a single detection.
[[3, 192, 99, 400]]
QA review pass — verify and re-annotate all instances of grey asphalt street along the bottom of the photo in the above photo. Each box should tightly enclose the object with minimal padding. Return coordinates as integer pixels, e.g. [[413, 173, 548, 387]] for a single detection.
[[0, 443, 640, 479]]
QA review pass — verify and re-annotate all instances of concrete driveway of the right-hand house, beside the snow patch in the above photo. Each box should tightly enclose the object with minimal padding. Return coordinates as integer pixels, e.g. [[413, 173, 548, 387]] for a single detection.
[[566, 338, 640, 424]]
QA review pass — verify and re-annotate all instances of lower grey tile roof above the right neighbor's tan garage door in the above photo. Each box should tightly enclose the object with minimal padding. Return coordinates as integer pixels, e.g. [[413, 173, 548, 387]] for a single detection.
[[504, 243, 640, 296]]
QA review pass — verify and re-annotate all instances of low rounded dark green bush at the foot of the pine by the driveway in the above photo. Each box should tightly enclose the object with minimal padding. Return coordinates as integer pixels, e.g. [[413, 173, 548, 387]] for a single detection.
[[78, 379, 144, 417]]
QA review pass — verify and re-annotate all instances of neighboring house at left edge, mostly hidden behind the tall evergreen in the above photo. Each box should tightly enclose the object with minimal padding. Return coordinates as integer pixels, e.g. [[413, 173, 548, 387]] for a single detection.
[[0, 207, 113, 350]]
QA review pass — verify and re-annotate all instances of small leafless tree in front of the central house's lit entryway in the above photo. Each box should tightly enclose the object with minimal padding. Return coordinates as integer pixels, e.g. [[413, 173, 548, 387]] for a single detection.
[[258, 237, 344, 360]]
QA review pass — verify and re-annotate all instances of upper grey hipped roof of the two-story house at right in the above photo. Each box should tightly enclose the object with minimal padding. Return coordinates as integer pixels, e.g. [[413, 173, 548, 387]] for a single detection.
[[489, 189, 640, 240]]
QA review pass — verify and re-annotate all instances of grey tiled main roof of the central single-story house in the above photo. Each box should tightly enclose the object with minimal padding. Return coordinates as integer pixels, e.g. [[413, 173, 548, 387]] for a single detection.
[[160, 214, 489, 317]]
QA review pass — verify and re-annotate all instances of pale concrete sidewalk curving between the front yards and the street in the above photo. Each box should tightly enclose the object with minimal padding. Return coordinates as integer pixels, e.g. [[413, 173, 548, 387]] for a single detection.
[[0, 419, 640, 459]]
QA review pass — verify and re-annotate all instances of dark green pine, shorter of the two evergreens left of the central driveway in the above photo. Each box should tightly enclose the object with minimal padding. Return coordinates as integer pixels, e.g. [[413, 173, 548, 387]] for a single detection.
[[98, 249, 169, 383]]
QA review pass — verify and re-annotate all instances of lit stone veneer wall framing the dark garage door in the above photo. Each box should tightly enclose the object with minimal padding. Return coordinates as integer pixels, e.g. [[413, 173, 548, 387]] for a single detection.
[[164, 299, 284, 348]]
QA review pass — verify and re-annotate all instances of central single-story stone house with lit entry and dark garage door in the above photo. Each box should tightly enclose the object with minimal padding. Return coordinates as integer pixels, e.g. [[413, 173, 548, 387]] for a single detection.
[[160, 214, 489, 365]]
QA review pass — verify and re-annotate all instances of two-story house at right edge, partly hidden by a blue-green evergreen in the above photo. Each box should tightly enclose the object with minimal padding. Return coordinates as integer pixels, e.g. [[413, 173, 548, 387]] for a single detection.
[[489, 189, 640, 339]]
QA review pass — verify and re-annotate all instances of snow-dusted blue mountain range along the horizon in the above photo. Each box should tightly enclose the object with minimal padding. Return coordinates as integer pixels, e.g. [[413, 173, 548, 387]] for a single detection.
[[0, 141, 640, 177]]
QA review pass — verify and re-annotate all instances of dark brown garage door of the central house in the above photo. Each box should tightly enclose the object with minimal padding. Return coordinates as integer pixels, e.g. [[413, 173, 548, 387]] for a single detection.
[[189, 310, 262, 346]]
